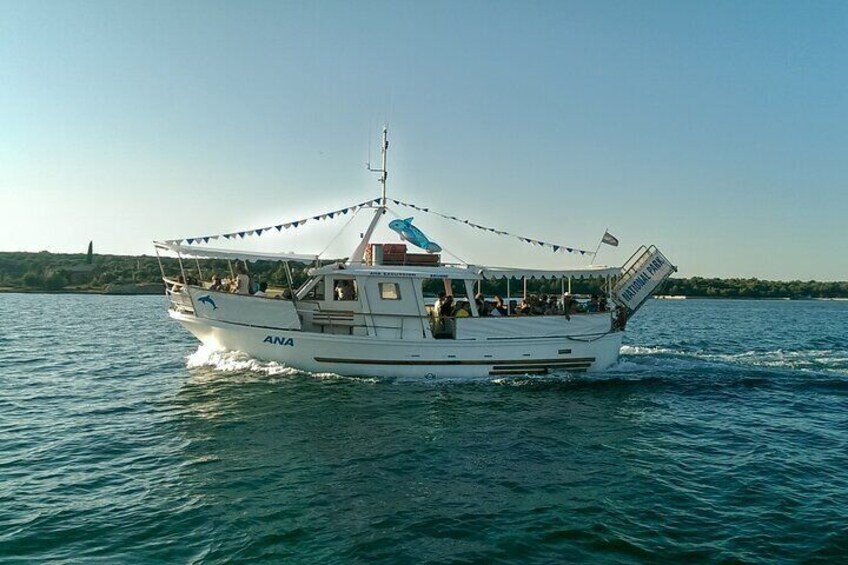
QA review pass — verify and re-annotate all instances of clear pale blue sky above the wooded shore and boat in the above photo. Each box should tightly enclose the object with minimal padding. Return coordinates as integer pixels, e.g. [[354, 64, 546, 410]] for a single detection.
[[0, 0, 848, 280]]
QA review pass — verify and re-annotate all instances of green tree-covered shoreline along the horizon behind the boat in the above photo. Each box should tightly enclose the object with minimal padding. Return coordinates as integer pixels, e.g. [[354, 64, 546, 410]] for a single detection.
[[0, 250, 848, 299]]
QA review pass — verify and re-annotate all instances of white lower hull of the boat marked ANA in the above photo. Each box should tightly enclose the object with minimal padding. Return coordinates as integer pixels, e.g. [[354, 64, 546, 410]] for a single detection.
[[170, 310, 622, 378]]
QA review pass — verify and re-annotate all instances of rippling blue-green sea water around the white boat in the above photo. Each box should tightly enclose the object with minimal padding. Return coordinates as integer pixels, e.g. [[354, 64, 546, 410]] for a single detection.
[[0, 294, 848, 563]]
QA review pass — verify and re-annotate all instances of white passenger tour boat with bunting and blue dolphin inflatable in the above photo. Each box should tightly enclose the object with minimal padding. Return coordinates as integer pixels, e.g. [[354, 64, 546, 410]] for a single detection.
[[154, 128, 677, 378]]
